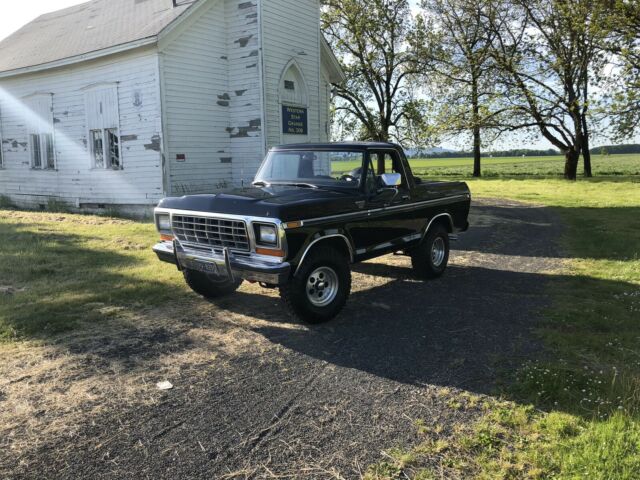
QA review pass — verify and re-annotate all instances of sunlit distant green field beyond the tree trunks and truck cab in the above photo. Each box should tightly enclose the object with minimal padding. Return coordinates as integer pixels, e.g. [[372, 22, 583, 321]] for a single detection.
[[333, 154, 640, 177]]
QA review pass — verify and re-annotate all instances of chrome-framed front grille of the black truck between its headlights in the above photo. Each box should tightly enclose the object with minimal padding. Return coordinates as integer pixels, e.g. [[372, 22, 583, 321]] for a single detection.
[[172, 215, 249, 252]]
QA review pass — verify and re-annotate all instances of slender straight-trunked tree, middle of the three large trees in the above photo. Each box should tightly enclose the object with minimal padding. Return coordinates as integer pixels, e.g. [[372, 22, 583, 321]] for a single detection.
[[419, 0, 504, 177]]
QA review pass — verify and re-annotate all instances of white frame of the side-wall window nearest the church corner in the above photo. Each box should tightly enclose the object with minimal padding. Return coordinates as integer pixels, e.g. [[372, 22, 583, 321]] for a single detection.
[[83, 82, 124, 171]]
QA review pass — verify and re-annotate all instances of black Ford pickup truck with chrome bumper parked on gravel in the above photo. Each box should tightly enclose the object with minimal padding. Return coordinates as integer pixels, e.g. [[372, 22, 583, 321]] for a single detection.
[[154, 143, 471, 323]]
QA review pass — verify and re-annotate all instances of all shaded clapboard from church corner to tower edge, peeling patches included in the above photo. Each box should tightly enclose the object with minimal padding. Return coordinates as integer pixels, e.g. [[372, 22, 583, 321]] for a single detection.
[[161, 0, 263, 195]]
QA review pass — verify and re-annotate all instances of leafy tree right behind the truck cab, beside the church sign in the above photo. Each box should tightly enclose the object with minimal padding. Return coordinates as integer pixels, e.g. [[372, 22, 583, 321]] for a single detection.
[[322, 0, 429, 146]]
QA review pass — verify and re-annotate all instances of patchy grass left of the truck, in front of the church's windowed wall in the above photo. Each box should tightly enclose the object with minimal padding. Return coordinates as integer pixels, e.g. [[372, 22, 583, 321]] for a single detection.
[[0, 210, 186, 342]]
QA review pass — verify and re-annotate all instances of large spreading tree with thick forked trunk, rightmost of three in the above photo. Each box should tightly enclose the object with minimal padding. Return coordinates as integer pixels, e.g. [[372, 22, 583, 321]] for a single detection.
[[491, 0, 608, 180]]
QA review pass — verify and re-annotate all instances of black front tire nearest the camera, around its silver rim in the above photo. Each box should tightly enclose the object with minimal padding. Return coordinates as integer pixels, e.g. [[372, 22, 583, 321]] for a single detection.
[[280, 247, 351, 323]]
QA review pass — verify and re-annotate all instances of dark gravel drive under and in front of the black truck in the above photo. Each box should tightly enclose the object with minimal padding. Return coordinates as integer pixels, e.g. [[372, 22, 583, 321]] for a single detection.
[[0, 200, 562, 479]]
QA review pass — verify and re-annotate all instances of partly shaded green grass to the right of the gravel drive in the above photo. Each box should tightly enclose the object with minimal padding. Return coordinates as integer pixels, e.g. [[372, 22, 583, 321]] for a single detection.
[[367, 176, 640, 480]]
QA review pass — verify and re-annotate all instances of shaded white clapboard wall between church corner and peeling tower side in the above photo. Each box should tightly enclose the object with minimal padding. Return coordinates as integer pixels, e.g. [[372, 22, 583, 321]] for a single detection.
[[160, 0, 232, 195]]
